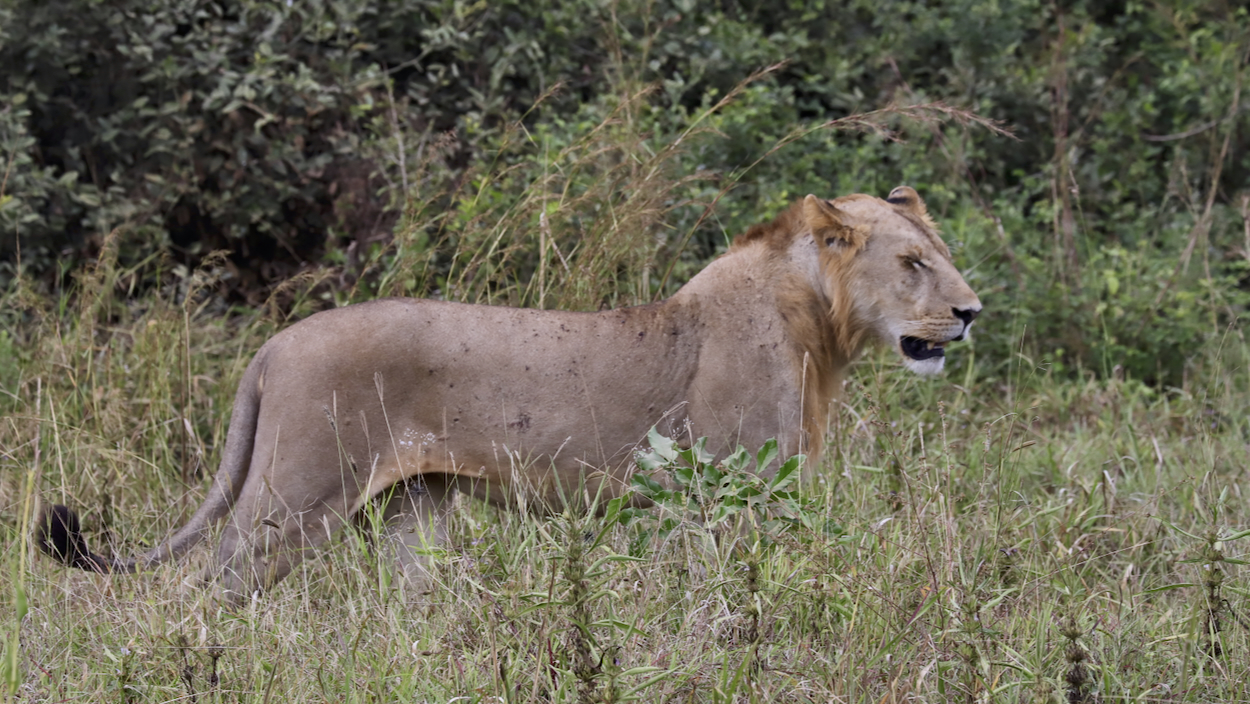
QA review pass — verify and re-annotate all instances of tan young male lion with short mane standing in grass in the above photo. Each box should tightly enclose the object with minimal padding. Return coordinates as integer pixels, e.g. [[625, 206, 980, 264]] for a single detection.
[[39, 186, 981, 601]]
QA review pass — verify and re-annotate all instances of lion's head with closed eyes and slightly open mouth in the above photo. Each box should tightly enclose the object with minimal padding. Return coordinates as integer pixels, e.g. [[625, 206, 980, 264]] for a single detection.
[[803, 186, 981, 374]]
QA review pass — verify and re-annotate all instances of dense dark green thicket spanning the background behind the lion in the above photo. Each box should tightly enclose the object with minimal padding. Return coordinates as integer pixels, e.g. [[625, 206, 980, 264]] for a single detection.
[[0, 0, 1250, 386]]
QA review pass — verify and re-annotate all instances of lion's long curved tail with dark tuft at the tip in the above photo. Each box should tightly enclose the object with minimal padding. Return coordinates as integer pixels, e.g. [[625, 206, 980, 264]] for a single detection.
[[36, 349, 265, 573]]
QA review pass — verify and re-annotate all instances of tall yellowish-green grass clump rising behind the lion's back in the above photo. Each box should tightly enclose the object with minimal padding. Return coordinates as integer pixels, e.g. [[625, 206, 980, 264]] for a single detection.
[[353, 83, 706, 310]]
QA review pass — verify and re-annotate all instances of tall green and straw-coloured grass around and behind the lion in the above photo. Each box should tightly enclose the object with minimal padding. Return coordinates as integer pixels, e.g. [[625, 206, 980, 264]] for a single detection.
[[0, 75, 1250, 703]]
